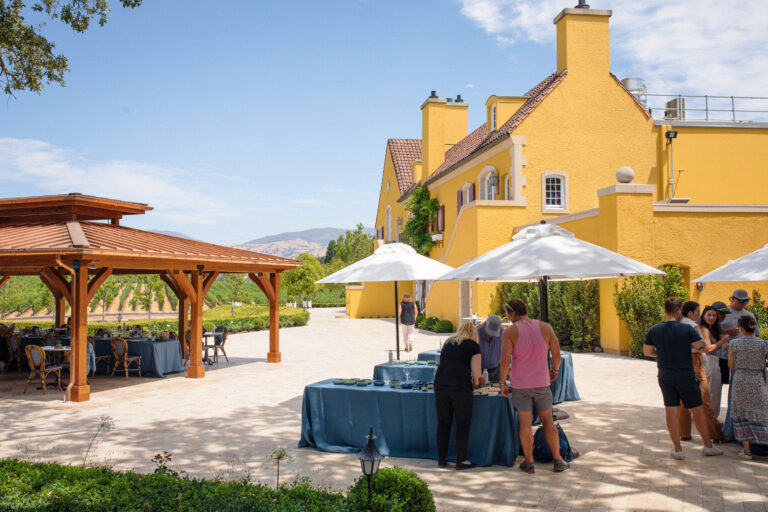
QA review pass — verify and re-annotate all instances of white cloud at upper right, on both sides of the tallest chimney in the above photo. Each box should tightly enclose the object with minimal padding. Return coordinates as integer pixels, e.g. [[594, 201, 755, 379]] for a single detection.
[[461, 0, 768, 97]]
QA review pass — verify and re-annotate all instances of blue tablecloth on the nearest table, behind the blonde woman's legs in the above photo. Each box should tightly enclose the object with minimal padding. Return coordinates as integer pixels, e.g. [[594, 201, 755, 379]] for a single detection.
[[299, 380, 520, 466]]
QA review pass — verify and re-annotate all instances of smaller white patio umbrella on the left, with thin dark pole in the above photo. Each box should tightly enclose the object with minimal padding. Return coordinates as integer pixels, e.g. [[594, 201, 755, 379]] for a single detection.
[[317, 243, 453, 359]]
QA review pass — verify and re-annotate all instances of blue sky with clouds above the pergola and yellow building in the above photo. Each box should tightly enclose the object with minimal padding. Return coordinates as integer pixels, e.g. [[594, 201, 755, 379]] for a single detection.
[[0, 0, 768, 244]]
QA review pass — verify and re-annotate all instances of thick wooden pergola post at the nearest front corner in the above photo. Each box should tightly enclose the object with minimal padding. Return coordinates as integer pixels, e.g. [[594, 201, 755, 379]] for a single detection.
[[69, 262, 91, 402]]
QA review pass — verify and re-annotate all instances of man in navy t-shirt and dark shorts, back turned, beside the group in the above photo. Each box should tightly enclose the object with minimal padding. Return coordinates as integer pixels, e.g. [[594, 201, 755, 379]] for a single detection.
[[643, 297, 723, 460]]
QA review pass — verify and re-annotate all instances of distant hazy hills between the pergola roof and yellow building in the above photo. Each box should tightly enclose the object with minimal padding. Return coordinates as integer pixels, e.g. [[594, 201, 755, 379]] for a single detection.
[[235, 228, 376, 258]]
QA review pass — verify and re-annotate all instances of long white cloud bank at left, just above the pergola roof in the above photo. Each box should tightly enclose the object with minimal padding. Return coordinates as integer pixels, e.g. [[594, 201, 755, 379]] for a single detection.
[[0, 137, 232, 225]]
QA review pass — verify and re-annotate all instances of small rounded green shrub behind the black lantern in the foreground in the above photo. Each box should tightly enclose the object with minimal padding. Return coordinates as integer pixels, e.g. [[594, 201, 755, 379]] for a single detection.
[[347, 467, 436, 512]]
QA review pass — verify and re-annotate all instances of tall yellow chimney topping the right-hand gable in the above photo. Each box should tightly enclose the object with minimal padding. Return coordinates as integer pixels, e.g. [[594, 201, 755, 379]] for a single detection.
[[554, 6, 611, 77]]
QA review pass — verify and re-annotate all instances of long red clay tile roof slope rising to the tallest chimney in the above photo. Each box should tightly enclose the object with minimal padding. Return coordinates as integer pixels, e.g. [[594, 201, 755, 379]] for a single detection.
[[427, 71, 567, 183]]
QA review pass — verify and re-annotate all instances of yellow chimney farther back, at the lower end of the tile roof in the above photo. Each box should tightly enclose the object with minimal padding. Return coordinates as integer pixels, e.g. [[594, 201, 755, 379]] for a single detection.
[[420, 91, 469, 178]]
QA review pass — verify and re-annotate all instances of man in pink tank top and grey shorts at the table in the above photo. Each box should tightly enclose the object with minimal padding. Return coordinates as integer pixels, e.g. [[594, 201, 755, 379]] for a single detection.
[[499, 299, 568, 473]]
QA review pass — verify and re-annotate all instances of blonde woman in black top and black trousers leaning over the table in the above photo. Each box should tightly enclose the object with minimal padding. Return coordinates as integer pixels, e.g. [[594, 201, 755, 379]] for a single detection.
[[435, 322, 482, 469]]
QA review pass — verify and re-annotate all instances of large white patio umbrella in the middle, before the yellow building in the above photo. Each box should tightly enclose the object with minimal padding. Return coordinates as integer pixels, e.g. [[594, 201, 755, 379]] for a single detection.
[[437, 221, 664, 322]]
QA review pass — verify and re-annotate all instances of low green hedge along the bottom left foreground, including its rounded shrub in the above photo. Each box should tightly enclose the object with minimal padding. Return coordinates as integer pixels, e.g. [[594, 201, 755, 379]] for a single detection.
[[0, 459, 435, 512]]
